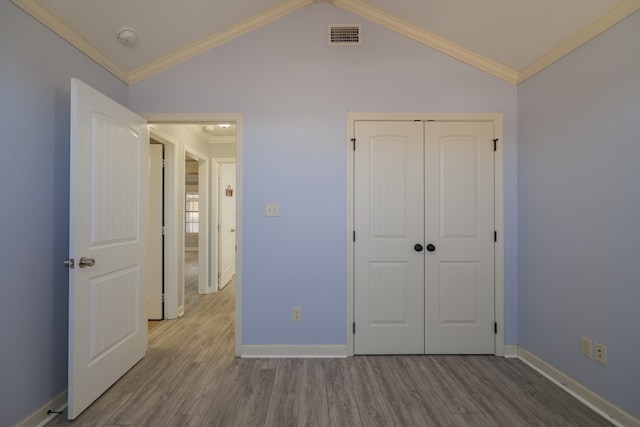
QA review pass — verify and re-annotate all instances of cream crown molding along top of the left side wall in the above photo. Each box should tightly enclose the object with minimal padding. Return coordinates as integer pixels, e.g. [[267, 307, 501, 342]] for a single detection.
[[11, 0, 130, 84]]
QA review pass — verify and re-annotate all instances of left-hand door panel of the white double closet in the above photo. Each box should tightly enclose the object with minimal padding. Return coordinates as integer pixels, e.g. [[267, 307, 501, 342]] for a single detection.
[[354, 122, 424, 354]]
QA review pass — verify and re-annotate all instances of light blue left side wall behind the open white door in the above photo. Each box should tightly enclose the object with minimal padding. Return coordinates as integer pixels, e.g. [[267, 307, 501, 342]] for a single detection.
[[0, 1, 128, 426]]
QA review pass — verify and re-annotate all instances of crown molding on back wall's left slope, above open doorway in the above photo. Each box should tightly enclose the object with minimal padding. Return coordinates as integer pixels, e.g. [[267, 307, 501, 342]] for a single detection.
[[129, 0, 313, 84]]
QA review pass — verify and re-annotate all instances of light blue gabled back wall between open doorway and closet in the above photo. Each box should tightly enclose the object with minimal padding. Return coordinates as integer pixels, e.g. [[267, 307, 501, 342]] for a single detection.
[[129, 4, 518, 344]]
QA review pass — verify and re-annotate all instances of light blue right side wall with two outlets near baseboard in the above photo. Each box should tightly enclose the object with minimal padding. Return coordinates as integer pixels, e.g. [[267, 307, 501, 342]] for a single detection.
[[518, 12, 640, 417]]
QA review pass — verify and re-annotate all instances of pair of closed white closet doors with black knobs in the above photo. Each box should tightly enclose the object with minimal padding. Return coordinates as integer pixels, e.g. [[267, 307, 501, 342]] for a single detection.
[[354, 121, 495, 354]]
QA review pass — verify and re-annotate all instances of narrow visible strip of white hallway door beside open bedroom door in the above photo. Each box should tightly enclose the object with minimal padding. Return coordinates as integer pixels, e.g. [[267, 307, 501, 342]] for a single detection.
[[147, 144, 164, 320]]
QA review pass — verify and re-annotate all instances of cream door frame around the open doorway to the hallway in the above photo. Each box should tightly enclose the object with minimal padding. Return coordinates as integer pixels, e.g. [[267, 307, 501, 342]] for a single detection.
[[140, 113, 243, 357]]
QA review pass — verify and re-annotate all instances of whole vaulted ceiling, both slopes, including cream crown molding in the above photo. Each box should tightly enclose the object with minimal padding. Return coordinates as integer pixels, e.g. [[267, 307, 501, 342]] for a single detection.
[[12, 0, 640, 84]]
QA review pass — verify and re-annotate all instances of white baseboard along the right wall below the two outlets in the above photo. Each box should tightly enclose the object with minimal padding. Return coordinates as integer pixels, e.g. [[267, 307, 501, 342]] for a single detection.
[[517, 346, 640, 427]]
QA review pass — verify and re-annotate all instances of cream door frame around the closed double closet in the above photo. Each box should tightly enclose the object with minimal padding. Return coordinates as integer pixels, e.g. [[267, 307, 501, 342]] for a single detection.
[[346, 113, 504, 356]]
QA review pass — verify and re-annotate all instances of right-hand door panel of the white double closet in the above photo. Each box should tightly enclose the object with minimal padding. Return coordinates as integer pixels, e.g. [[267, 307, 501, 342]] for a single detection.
[[425, 122, 495, 354]]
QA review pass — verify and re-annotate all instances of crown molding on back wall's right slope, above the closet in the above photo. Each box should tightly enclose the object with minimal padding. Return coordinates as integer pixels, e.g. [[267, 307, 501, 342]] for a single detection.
[[333, 0, 518, 84]]
